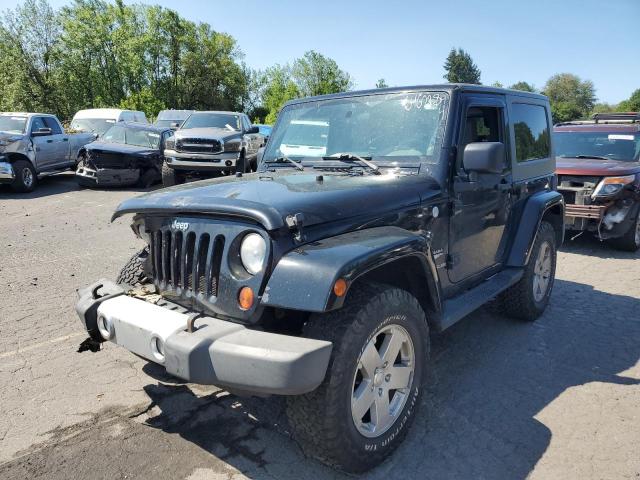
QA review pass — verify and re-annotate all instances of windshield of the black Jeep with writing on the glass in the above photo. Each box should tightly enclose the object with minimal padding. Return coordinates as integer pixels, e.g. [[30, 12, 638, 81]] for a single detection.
[[264, 92, 448, 164]]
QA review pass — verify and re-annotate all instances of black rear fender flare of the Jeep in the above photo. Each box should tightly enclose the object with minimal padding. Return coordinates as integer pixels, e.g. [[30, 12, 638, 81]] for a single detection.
[[506, 190, 564, 267]]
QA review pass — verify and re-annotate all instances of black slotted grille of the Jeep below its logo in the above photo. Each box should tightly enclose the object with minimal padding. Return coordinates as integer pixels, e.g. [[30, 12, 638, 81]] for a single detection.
[[150, 227, 225, 297]]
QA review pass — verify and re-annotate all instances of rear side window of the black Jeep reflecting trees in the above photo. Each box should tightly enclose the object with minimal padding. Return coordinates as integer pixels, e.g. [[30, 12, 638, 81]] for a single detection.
[[511, 103, 551, 163]]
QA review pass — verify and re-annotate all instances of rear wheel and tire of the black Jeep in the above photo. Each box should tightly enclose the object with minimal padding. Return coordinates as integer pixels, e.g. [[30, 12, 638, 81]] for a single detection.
[[498, 221, 558, 322]]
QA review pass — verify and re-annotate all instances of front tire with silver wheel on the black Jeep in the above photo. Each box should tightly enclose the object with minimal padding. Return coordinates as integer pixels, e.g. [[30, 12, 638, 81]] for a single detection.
[[287, 284, 429, 473]]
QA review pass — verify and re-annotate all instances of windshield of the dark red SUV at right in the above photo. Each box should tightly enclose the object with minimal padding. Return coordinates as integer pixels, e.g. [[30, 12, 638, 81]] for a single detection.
[[554, 132, 640, 162]]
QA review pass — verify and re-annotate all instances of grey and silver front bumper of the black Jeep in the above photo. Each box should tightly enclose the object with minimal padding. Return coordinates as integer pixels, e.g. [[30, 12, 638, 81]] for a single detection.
[[76, 280, 332, 395]]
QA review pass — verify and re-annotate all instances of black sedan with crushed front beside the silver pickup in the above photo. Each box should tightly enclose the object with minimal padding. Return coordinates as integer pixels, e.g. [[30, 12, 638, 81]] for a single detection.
[[76, 122, 173, 188]]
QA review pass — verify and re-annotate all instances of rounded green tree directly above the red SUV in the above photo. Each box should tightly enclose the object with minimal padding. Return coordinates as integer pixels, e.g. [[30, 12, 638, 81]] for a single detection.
[[543, 73, 596, 122]]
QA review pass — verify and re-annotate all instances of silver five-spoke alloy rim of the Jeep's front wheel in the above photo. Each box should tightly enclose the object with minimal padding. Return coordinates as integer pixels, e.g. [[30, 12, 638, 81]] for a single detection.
[[351, 324, 415, 438]]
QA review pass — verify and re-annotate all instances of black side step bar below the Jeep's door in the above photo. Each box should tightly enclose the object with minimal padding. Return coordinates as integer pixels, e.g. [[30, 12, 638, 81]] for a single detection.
[[438, 268, 524, 331]]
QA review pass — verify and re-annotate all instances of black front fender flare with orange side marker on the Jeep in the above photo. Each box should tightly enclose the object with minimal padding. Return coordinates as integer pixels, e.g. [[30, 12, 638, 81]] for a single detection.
[[262, 226, 432, 312]]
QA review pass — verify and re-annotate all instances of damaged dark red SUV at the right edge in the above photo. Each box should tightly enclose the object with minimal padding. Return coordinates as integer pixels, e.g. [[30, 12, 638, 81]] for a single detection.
[[554, 113, 640, 251]]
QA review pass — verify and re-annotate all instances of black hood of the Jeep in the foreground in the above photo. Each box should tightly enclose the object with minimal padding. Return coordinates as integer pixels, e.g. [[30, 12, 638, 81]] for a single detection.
[[112, 172, 440, 230]]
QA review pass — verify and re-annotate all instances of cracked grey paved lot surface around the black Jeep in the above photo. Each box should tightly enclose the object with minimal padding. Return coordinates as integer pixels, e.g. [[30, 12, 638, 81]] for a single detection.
[[0, 175, 640, 480]]
